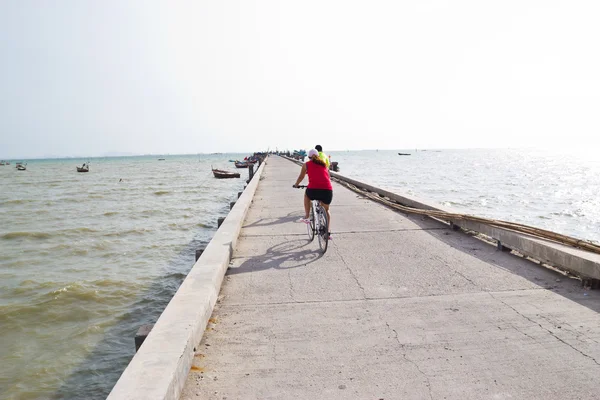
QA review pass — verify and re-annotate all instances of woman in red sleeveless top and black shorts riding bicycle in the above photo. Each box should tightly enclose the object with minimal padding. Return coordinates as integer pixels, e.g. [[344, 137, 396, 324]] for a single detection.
[[294, 149, 333, 235]]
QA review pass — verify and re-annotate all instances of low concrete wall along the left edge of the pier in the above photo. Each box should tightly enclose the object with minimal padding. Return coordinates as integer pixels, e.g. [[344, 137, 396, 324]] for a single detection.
[[108, 162, 266, 400]]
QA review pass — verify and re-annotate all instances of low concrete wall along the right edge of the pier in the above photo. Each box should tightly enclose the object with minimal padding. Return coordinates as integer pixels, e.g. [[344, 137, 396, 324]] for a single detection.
[[284, 157, 600, 279]]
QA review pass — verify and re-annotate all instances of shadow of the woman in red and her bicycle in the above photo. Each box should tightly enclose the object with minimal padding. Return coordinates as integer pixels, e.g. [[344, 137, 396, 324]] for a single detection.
[[227, 237, 323, 275]]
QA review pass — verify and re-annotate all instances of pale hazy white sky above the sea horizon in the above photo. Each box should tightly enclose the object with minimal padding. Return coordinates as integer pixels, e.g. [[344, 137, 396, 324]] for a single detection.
[[0, 0, 600, 158]]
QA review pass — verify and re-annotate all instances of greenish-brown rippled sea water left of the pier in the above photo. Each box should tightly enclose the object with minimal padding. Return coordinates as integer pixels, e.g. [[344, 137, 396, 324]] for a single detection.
[[0, 154, 247, 399]]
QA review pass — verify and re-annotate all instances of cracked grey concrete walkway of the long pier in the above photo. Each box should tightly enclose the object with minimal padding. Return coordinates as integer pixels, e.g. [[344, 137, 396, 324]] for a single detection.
[[182, 157, 600, 400]]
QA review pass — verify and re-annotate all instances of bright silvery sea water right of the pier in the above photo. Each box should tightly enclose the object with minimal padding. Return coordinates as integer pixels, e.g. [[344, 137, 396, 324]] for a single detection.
[[331, 149, 600, 242]]
